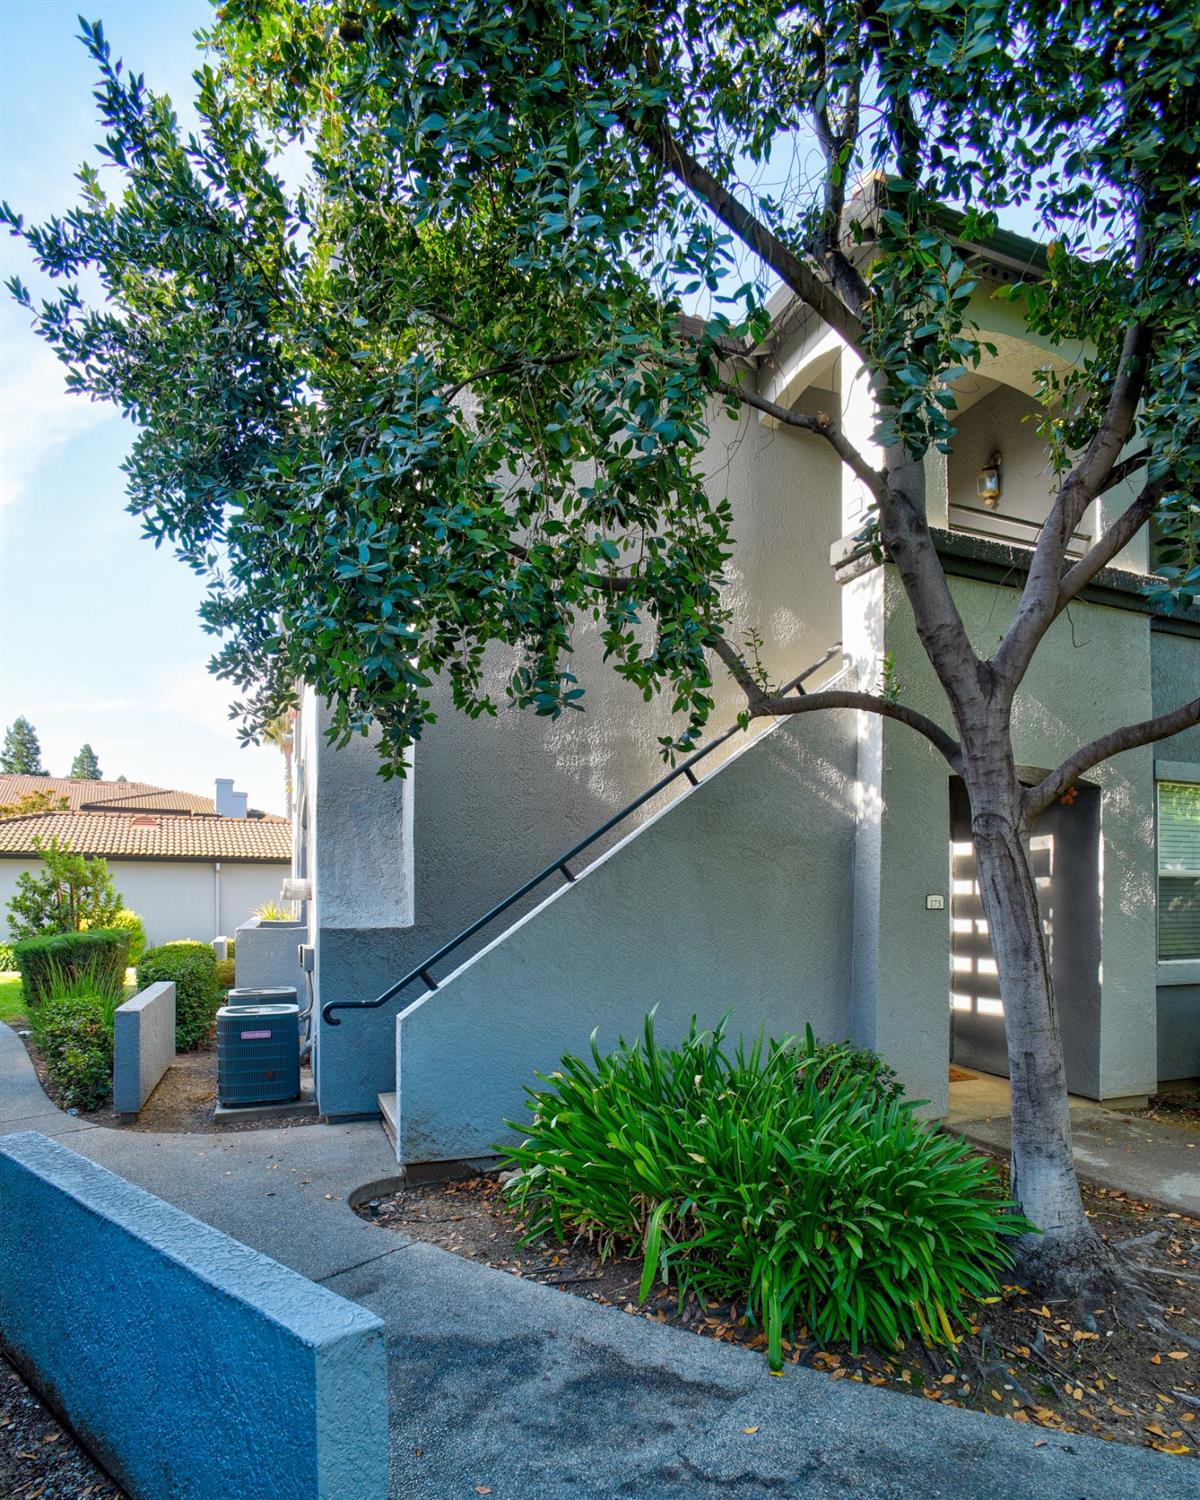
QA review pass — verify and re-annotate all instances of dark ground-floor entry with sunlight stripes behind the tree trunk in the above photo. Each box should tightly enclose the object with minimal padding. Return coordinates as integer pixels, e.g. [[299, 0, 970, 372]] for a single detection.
[[950, 777, 1100, 1094]]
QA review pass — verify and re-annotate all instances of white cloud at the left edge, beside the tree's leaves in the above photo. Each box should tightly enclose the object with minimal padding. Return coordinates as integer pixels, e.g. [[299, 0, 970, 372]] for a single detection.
[[0, 330, 116, 506]]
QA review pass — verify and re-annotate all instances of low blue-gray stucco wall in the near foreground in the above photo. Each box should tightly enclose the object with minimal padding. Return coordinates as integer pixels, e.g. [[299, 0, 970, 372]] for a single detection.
[[0, 1131, 387, 1500]]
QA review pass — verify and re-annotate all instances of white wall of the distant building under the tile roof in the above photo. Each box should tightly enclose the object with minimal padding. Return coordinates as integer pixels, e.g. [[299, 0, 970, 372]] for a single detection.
[[0, 860, 288, 945]]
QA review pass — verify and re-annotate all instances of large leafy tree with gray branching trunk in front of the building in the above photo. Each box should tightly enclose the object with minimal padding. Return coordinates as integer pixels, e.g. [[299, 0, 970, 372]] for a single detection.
[[5, 0, 1200, 1305]]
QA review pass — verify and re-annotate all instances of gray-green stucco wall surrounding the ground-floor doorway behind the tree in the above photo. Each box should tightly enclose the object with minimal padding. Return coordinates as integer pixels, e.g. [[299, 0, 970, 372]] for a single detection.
[[881, 569, 1157, 1098]]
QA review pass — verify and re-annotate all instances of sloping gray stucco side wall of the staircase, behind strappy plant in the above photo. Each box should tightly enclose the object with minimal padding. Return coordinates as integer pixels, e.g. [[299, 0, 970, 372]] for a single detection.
[[396, 713, 864, 1163]]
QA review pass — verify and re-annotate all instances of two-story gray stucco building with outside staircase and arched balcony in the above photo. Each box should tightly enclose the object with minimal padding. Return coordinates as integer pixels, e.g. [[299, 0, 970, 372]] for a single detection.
[[258, 214, 1200, 1163]]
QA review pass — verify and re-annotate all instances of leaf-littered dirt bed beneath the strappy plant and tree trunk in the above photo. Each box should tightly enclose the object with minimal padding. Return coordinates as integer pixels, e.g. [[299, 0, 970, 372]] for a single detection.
[[359, 1158, 1200, 1457]]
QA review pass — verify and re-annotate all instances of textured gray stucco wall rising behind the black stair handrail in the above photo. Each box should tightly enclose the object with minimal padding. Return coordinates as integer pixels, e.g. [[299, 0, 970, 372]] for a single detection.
[[313, 395, 842, 1115]]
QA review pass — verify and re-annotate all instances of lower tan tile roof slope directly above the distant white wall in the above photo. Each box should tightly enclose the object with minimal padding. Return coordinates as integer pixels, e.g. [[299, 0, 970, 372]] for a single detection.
[[0, 812, 291, 863]]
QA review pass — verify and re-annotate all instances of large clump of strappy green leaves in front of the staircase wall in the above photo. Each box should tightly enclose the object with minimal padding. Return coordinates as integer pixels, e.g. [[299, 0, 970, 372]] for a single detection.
[[507, 1014, 1029, 1370]]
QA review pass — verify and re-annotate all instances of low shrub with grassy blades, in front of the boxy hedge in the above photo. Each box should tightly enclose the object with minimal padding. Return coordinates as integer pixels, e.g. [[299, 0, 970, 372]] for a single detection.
[[30, 960, 122, 1110]]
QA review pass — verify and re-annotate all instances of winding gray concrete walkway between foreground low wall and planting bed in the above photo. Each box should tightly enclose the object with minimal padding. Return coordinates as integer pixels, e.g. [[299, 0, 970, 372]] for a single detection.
[[0, 1026, 1200, 1500]]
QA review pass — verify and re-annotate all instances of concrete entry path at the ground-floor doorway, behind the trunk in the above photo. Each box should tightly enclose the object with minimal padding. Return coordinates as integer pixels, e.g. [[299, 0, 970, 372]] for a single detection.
[[947, 1073, 1200, 1218]]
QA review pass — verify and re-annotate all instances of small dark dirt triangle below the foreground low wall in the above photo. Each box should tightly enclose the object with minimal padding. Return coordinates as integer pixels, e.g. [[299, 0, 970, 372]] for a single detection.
[[0, 1359, 125, 1500]]
